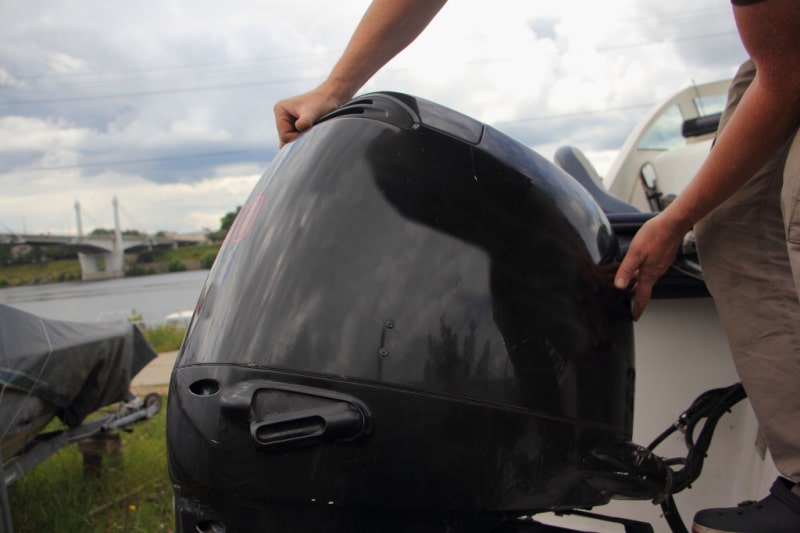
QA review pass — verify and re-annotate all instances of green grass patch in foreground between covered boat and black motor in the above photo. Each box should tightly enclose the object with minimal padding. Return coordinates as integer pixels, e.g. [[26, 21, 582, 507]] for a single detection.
[[9, 398, 175, 533]]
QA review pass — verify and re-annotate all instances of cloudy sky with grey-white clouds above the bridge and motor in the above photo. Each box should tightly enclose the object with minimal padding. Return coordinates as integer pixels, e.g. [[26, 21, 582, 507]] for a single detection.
[[0, 0, 745, 234]]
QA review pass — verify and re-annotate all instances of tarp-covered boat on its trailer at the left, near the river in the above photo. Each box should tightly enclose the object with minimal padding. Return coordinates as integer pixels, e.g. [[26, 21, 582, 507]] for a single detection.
[[0, 304, 161, 490]]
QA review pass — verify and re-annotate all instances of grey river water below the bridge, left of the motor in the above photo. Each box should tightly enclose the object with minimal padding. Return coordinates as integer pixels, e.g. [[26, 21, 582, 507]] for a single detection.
[[0, 270, 208, 325]]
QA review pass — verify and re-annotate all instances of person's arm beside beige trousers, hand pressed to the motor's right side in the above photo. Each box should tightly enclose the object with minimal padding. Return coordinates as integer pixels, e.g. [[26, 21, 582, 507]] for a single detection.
[[615, 0, 800, 318]]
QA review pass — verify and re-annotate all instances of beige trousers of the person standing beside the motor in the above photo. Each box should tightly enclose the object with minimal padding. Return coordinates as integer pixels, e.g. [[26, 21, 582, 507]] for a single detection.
[[695, 62, 800, 482]]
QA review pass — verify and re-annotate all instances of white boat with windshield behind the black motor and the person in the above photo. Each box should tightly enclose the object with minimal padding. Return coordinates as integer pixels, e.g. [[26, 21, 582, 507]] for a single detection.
[[554, 79, 778, 533]]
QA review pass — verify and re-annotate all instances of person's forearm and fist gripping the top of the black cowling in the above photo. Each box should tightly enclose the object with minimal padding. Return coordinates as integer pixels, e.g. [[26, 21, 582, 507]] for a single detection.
[[274, 0, 446, 146]]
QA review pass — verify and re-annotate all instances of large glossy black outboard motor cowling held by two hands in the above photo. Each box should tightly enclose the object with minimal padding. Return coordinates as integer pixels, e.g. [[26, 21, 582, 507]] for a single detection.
[[167, 93, 634, 533]]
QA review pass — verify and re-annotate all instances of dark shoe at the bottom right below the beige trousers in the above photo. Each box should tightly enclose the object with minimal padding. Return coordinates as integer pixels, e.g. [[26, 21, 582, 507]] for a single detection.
[[692, 478, 800, 533]]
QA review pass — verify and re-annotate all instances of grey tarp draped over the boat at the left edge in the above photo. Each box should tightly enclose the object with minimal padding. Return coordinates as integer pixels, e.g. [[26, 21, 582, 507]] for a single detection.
[[0, 304, 156, 427]]
